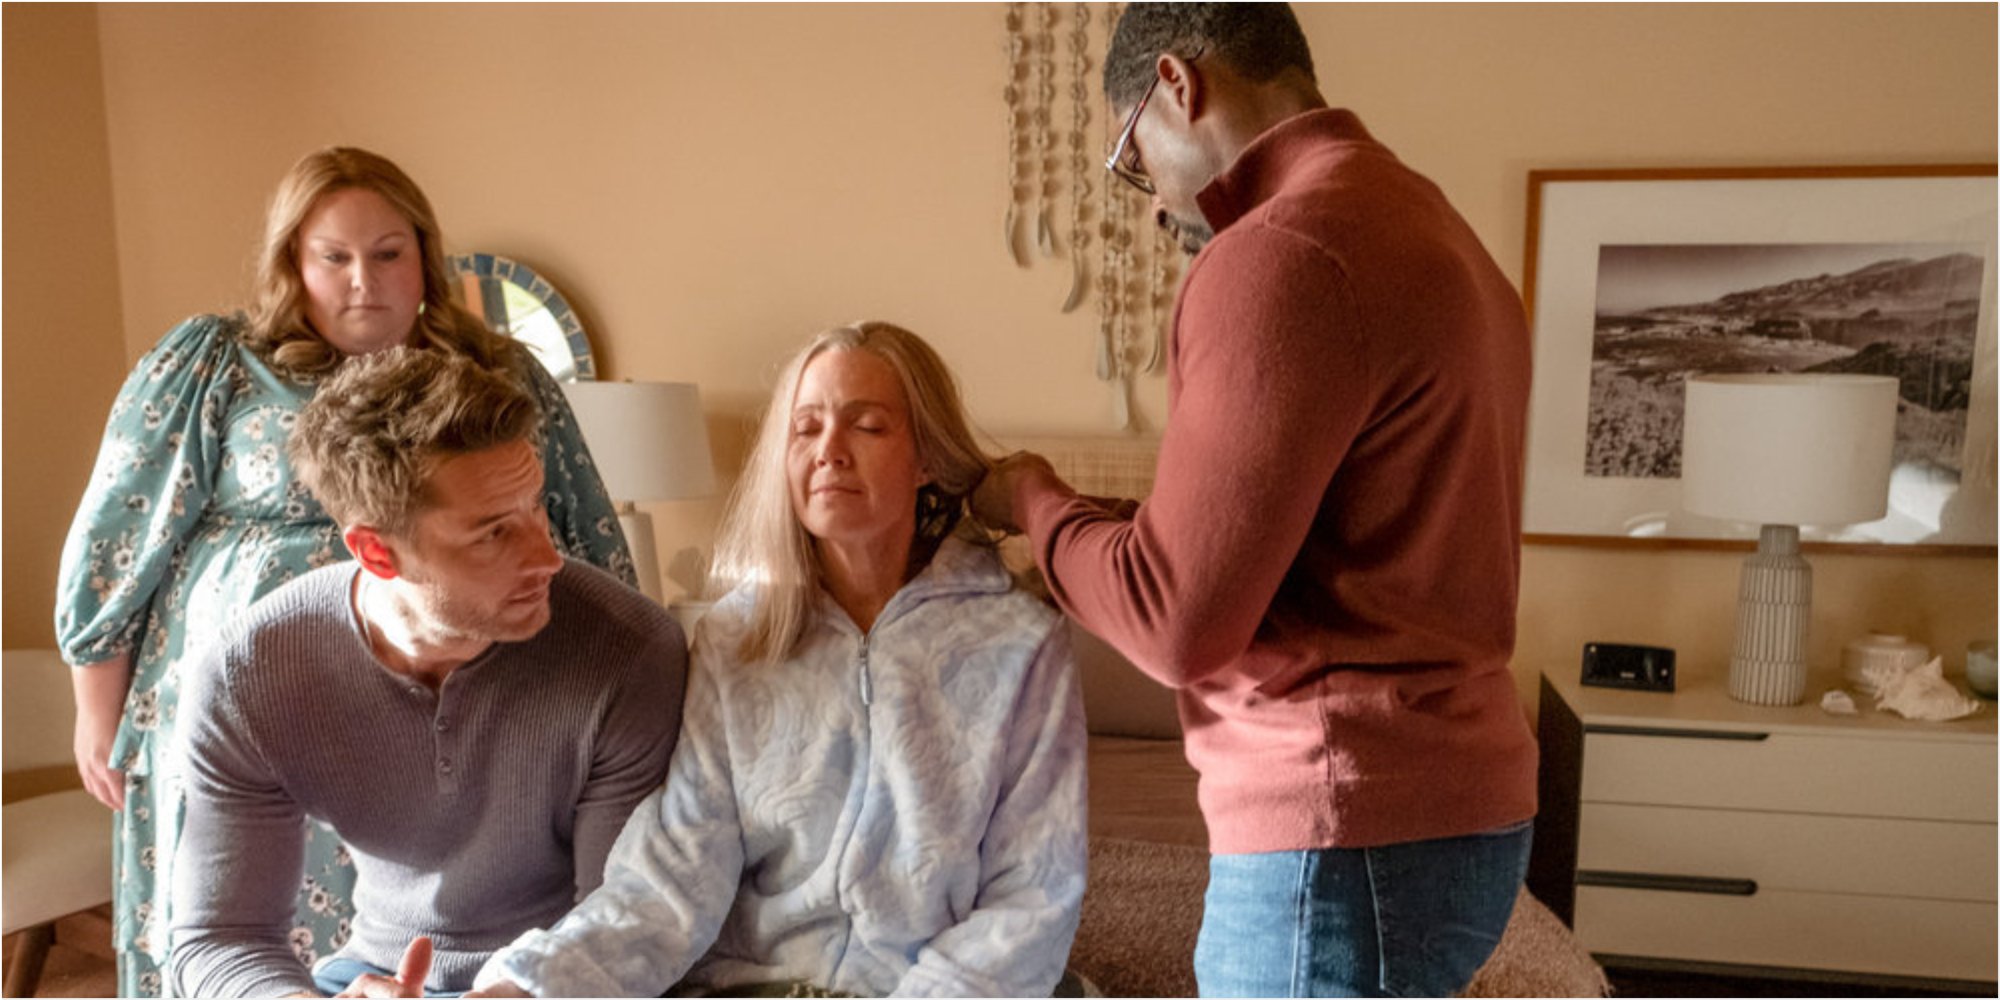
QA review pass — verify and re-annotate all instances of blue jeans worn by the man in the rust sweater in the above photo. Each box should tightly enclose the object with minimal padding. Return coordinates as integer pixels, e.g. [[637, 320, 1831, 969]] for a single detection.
[[1194, 822, 1532, 996]]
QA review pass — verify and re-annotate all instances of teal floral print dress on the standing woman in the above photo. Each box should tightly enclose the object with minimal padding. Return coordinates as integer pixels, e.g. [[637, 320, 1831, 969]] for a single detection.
[[56, 316, 634, 996]]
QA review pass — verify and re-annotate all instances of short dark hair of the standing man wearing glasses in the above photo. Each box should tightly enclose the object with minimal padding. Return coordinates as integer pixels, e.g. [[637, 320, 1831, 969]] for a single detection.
[[1104, 4, 1312, 108]]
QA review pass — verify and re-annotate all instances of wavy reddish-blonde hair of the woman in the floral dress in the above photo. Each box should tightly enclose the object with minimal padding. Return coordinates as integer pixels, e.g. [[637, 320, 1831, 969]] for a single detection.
[[242, 146, 524, 378]]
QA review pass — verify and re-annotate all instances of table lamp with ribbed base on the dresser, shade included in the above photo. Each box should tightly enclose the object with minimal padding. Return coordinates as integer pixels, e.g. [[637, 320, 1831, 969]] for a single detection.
[[1680, 374, 1896, 704]]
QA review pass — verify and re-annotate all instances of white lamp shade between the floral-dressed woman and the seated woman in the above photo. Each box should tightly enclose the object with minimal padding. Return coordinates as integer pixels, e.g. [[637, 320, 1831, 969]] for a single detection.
[[562, 382, 716, 502]]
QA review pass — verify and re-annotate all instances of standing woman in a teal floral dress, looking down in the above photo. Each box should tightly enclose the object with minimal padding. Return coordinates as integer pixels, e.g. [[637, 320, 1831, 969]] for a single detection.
[[56, 148, 634, 996]]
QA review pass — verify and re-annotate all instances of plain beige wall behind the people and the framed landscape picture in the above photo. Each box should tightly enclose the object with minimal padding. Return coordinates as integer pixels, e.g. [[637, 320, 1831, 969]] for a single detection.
[[6, 4, 1996, 704]]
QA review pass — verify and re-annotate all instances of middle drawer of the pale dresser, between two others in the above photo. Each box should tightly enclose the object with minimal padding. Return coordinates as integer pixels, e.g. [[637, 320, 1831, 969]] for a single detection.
[[1576, 802, 2000, 906]]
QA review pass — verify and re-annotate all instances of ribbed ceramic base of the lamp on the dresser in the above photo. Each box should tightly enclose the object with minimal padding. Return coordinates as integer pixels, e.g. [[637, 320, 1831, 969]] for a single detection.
[[1730, 524, 1812, 704]]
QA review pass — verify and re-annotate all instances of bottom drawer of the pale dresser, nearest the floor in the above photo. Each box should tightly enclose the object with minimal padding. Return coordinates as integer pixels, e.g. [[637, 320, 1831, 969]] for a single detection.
[[1576, 886, 1996, 980]]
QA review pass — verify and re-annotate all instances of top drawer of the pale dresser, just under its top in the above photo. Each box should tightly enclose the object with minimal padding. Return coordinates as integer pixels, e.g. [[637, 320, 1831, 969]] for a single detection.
[[1580, 728, 2000, 824]]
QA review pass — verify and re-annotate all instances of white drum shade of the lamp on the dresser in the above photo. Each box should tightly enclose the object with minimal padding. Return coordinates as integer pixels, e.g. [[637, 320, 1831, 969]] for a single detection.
[[1680, 374, 1896, 524]]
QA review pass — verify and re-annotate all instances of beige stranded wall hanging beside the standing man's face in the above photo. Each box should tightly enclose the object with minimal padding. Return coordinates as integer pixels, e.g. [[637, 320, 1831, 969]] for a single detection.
[[1002, 4, 1180, 430]]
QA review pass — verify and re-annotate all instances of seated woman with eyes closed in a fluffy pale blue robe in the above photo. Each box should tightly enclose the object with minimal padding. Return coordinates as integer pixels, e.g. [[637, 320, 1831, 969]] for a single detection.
[[480, 322, 1086, 996]]
